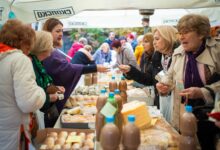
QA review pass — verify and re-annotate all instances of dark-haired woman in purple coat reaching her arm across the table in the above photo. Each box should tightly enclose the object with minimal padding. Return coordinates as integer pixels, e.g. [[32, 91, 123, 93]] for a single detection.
[[43, 18, 108, 127]]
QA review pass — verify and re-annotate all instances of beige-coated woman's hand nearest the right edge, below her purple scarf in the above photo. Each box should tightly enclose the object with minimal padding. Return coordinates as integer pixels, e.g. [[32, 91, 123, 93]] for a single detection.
[[179, 87, 204, 99]]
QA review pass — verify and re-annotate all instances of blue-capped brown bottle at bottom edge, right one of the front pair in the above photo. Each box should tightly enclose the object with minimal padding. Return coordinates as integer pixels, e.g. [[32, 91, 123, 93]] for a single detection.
[[122, 115, 141, 150]]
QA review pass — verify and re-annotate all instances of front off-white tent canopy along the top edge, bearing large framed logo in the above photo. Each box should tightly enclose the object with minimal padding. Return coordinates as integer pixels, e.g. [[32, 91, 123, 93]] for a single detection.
[[0, 0, 220, 23]]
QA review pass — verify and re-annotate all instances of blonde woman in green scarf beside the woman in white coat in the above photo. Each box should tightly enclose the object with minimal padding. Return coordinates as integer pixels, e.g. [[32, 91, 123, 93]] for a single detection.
[[29, 31, 65, 127]]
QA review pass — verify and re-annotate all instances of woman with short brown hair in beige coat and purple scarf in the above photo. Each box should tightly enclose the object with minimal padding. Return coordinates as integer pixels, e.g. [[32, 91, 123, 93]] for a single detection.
[[157, 14, 220, 150]]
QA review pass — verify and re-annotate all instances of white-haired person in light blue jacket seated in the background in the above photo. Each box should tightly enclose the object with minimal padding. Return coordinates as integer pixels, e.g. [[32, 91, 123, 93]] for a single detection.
[[93, 43, 112, 64]]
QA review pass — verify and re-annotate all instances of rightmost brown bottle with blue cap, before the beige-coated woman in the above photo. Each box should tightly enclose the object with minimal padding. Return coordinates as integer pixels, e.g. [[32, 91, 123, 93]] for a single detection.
[[179, 106, 197, 150]]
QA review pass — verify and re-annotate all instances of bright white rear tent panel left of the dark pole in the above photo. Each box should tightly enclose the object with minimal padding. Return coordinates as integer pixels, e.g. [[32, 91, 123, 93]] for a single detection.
[[61, 10, 142, 30]]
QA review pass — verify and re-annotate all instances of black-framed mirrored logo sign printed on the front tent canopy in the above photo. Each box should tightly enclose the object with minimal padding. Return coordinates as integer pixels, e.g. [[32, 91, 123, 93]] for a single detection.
[[34, 7, 75, 21]]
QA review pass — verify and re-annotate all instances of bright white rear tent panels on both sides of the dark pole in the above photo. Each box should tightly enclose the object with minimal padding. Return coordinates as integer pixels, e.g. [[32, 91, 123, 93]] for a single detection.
[[58, 8, 220, 30]]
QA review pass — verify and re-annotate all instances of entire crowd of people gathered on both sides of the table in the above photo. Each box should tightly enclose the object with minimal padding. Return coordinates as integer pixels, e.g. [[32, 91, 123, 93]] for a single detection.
[[0, 14, 220, 150]]
